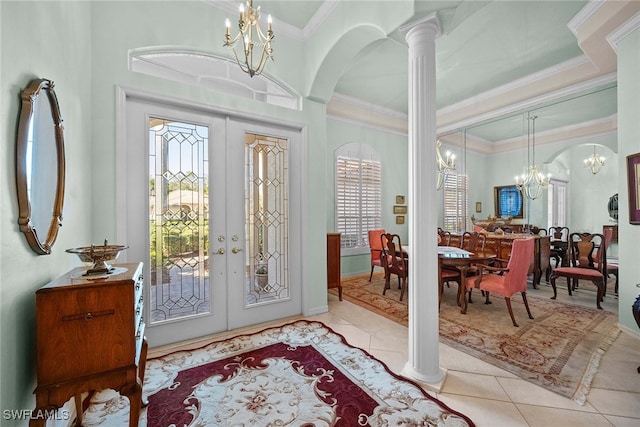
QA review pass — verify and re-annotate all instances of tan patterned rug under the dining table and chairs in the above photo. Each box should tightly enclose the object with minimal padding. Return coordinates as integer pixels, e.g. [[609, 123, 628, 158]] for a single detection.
[[331, 273, 620, 404]]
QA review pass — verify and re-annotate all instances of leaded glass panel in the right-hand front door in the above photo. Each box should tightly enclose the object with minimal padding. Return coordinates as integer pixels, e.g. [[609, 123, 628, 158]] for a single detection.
[[245, 134, 289, 306]]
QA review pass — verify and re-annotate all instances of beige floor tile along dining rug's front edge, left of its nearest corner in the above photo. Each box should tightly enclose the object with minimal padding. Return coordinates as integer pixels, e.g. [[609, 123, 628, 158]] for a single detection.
[[497, 378, 597, 412]]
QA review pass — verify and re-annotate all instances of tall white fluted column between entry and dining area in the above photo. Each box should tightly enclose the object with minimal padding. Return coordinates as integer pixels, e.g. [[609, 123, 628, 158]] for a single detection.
[[401, 14, 445, 389]]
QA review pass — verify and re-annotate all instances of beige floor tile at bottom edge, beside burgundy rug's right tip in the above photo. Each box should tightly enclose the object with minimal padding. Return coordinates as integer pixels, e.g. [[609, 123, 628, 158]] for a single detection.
[[437, 393, 528, 427]]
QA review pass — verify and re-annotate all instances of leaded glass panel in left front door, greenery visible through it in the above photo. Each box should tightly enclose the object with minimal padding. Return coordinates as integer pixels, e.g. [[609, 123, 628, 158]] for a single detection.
[[149, 118, 210, 324]]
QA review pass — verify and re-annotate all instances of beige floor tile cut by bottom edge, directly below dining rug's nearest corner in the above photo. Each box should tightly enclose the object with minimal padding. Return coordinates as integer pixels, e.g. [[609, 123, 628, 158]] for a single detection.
[[516, 404, 611, 427]]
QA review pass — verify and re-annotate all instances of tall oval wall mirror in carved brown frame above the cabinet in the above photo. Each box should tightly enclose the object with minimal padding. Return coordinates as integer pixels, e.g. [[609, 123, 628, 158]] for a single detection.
[[16, 79, 65, 255]]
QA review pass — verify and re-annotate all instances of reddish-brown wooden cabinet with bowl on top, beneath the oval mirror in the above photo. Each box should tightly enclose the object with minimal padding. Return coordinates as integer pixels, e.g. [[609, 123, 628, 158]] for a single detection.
[[30, 263, 147, 426]]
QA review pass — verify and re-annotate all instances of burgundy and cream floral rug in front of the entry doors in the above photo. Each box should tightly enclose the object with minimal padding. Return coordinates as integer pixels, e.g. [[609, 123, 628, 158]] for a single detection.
[[83, 320, 474, 427]]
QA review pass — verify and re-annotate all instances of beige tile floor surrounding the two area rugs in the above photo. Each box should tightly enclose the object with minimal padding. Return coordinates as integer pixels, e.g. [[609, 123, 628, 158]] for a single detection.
[[149, 282, 640, 427]]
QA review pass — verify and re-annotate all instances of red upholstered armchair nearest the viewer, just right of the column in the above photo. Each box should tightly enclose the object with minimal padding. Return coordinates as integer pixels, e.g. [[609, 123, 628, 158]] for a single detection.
[[462, 237, 534, 327]]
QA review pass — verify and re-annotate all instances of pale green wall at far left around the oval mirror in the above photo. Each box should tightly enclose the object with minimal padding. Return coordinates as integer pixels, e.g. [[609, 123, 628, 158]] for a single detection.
[[0, 1, 93, 426]]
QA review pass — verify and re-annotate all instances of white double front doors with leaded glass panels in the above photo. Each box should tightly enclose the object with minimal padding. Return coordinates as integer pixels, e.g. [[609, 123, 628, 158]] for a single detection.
[[121, 94, 302, 346]]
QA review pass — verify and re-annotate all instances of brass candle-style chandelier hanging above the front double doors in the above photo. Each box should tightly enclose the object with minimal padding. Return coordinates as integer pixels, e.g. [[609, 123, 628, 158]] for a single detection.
[[224, 0, 273, 77]]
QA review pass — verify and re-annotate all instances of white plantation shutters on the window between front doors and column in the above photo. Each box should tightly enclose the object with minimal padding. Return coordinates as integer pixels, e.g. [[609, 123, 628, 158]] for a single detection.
[[336, 156, 382, 248]]
